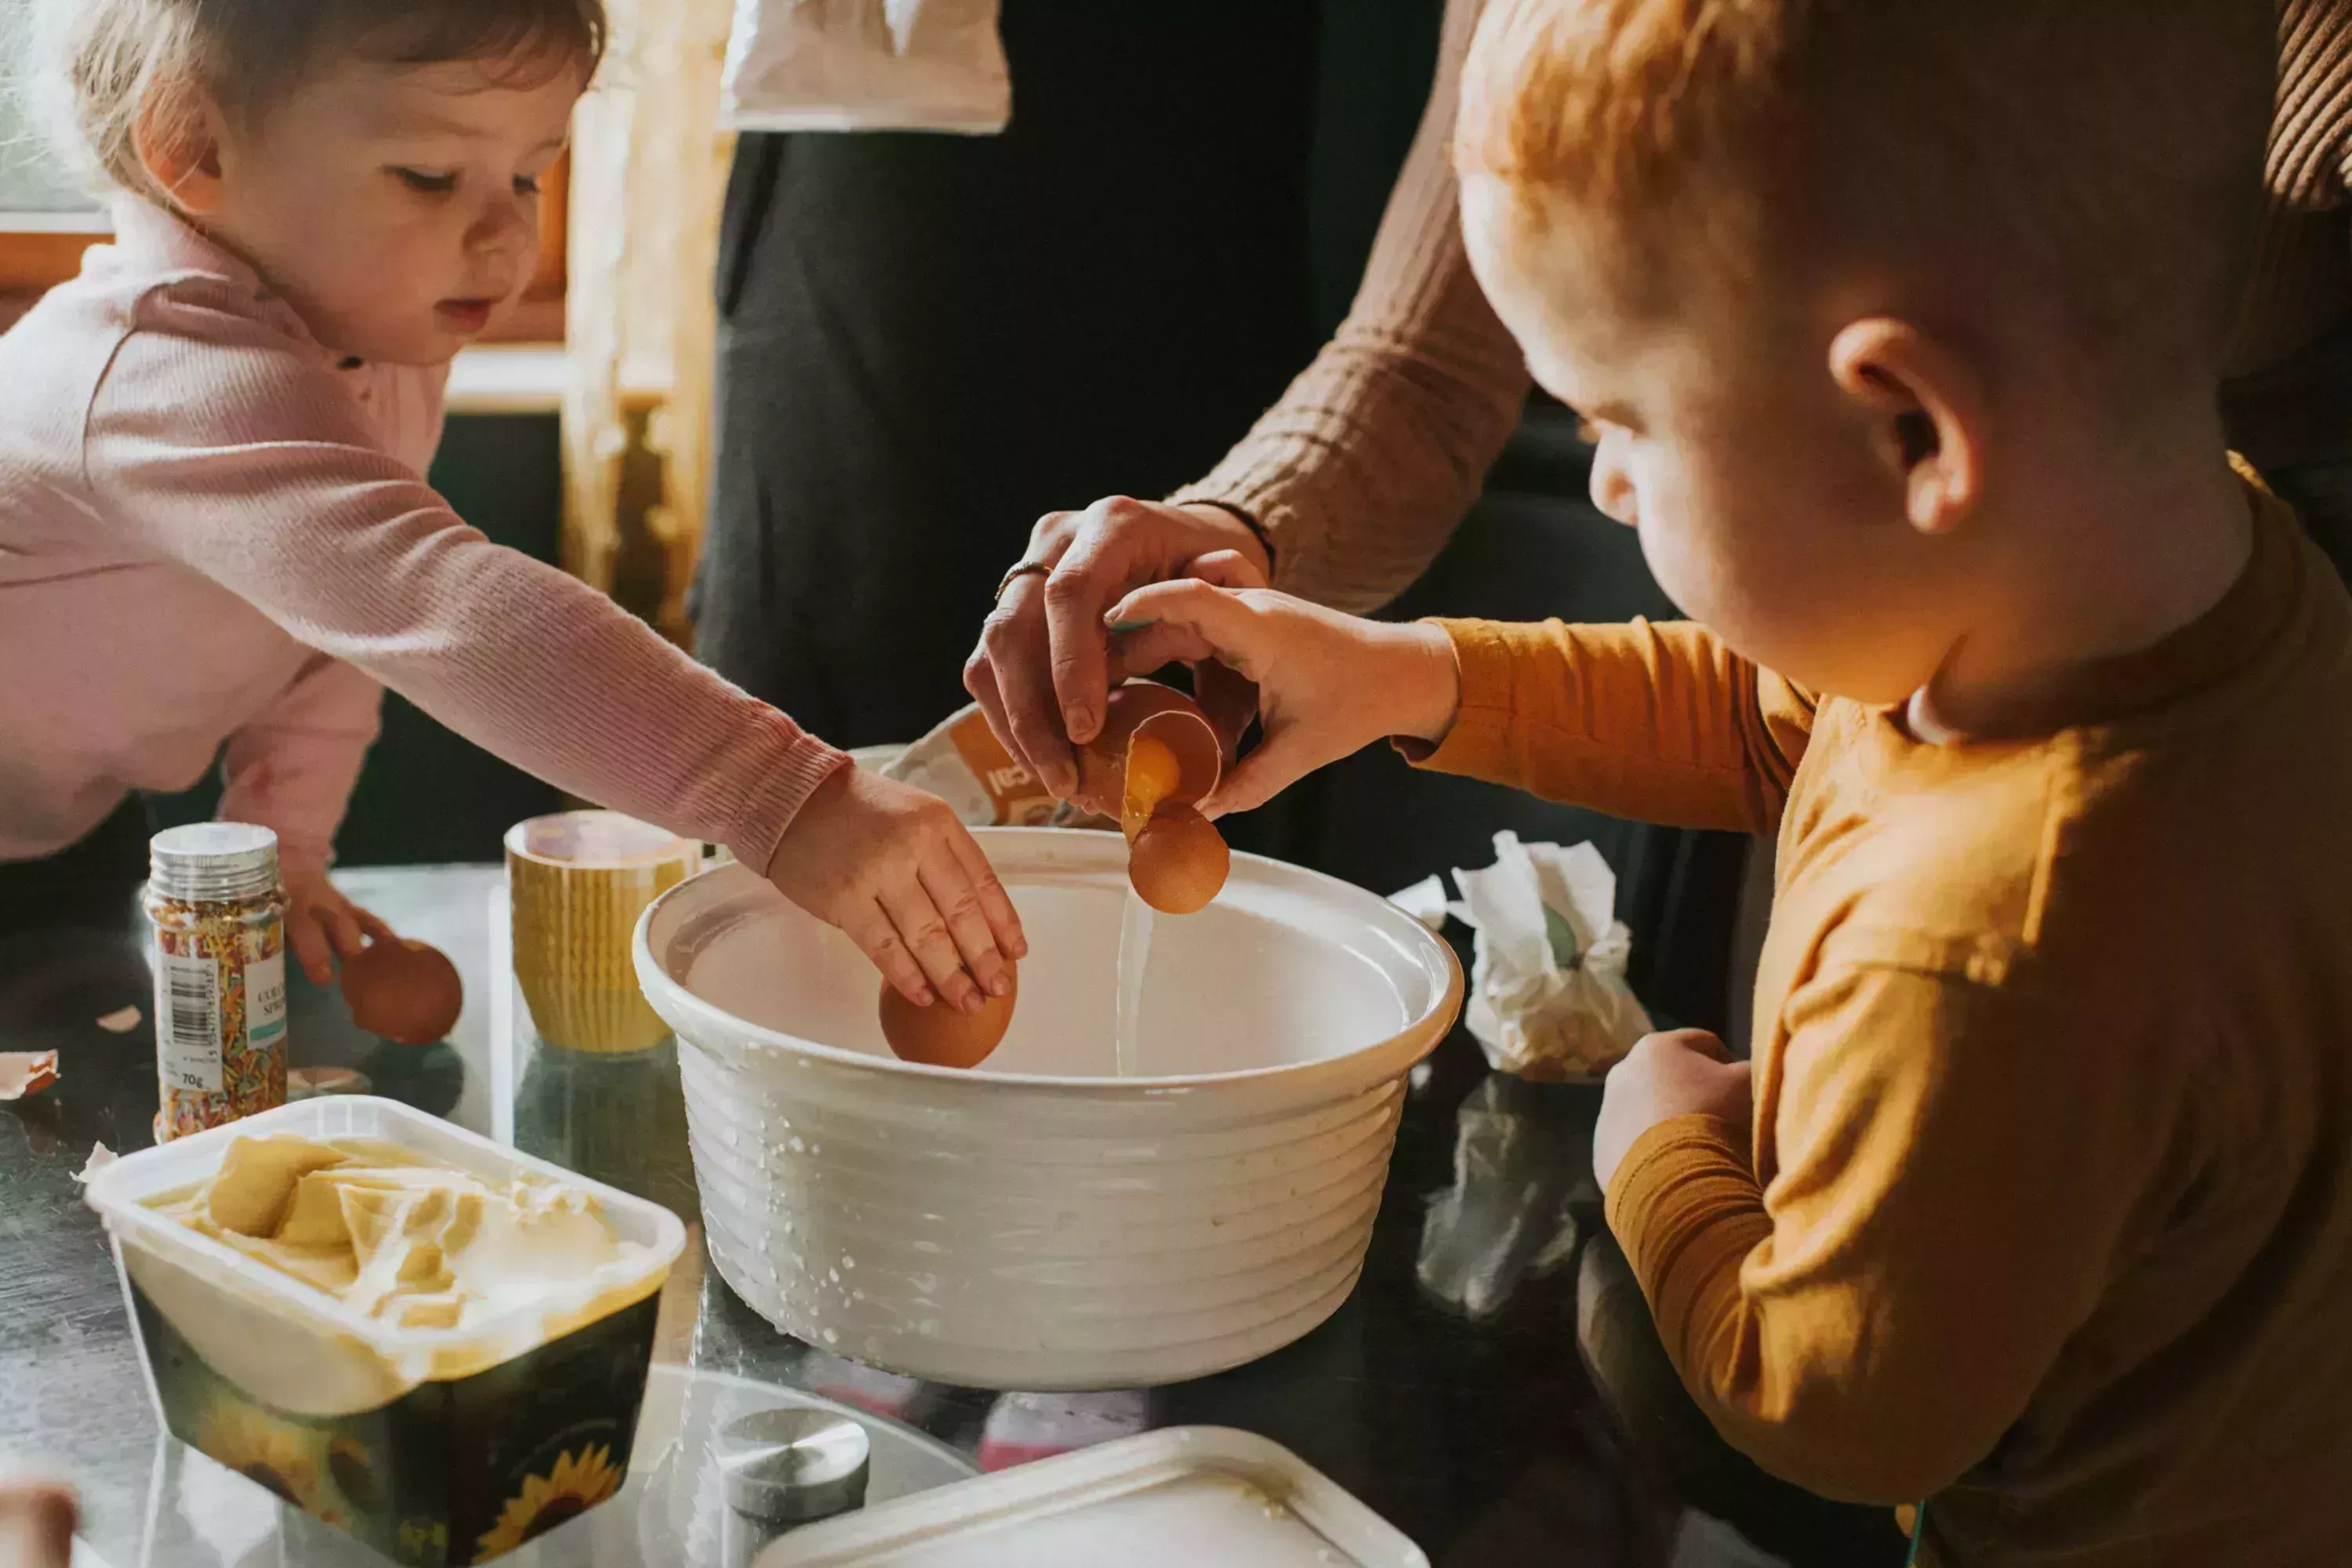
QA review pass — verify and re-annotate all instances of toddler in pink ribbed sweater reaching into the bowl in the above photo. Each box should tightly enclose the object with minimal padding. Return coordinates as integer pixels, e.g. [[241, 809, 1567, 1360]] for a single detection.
[[0, 0, 1023, 1008]]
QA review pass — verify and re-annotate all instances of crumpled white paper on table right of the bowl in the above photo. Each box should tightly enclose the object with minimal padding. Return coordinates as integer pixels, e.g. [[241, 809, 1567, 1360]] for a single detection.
[[1399, 832, 1651, 1083]]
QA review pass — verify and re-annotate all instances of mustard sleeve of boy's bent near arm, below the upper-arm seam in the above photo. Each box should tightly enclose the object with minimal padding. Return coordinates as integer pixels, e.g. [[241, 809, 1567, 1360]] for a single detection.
[[1604, 938, 2154, 1504]]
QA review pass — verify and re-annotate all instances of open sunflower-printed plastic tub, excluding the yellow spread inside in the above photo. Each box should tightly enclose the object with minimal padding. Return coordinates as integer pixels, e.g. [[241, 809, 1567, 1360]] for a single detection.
[[87, 1098, 684, 1568]]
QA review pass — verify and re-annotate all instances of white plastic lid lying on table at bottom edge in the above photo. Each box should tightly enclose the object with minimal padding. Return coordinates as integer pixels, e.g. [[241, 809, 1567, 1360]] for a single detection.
[[755, 1427, 1430, 1568]]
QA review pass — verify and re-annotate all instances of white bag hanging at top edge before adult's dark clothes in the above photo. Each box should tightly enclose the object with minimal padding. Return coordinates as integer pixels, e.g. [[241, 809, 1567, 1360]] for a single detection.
[[720, 0, 1014, 136]]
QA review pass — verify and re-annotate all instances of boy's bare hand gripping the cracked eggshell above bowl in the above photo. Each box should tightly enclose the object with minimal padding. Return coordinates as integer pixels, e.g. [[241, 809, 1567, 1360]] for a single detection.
[[1108, 562, 1461, 815]]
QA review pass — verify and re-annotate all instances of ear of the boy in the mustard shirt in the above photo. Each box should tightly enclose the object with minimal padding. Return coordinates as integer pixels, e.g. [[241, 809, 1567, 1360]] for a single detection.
[[1830, 318, 1985, 534]]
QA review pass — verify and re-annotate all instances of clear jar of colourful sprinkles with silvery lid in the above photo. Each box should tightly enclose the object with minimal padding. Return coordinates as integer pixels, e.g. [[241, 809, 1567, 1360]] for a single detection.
[[146, 822, 287, 1142]]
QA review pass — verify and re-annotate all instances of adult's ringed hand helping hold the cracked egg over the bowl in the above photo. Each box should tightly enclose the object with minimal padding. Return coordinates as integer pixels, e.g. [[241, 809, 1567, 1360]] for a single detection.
[[964, 496, 1270, 811]]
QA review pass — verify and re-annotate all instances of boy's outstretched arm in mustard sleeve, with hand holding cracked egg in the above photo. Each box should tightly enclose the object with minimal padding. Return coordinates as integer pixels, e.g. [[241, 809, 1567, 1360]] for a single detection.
[[1108, 567, 1813, 832]]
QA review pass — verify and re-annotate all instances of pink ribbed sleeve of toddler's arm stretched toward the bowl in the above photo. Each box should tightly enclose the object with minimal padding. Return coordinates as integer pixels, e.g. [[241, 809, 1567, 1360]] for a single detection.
[[85, 280, 847, 867]]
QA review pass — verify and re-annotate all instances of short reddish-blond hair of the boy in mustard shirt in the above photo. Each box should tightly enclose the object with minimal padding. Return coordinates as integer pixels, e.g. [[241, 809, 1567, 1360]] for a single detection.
[[1456, 0, 2277, 383]]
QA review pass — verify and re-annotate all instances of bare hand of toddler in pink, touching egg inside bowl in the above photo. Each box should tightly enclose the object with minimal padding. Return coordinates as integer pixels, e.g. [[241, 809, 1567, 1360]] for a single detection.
[[767, 769, 1028, 1013]]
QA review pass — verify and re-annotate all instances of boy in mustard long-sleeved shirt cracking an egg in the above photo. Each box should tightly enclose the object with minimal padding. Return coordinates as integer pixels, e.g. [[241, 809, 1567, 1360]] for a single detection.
[[1110, 0, 2352, 1568]]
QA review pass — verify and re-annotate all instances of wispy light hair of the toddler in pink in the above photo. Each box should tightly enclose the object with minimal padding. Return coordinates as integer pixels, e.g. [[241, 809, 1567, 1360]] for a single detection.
[[35, 0, 607, 195]]
